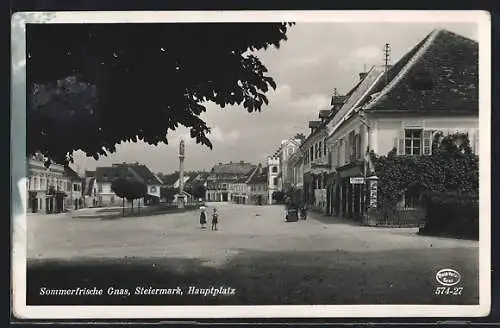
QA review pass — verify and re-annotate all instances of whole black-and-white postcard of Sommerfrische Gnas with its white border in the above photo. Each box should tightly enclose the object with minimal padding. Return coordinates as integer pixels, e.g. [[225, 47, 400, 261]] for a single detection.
[[11, 11, 491, 319]]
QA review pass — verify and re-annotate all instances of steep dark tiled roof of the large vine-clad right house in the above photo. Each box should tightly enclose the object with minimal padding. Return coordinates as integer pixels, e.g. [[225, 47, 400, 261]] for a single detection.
[[367, 30, 479, 112]]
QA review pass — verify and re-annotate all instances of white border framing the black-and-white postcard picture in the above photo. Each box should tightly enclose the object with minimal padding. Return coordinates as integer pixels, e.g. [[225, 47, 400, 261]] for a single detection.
[[11, 11, 491, 319]]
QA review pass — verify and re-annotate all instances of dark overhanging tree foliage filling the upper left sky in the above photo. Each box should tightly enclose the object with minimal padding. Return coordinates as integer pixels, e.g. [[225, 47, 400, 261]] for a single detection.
[[26, 23, 291, 167]]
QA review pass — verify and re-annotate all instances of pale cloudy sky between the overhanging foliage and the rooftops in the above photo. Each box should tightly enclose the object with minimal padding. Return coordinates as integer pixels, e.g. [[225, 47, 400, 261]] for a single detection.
[[69, 23, 478, 173]]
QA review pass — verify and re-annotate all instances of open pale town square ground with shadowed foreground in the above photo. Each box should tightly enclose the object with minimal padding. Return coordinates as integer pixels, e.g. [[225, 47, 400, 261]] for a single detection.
[[28, 203, 478, 305]]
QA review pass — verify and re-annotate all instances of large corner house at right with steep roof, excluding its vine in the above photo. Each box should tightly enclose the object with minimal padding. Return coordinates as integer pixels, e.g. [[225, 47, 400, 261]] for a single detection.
[[325, 30, 479, 220]]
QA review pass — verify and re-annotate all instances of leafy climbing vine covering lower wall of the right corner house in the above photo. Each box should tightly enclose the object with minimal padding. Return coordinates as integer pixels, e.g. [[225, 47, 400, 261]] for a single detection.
[[370, 132, 479, 207]]
